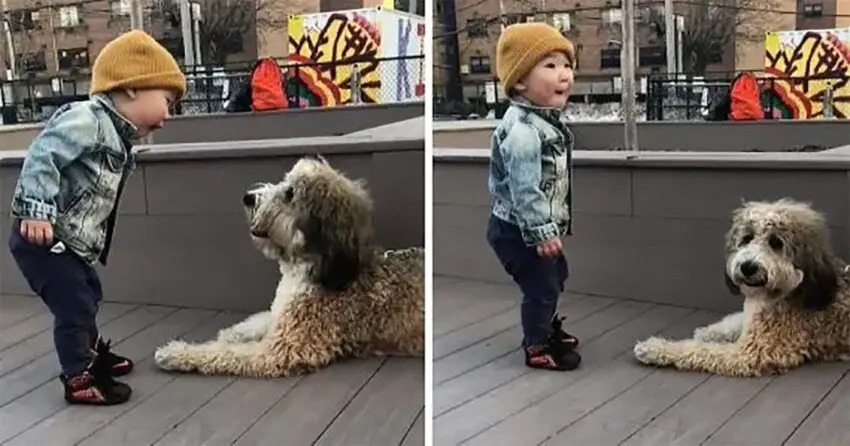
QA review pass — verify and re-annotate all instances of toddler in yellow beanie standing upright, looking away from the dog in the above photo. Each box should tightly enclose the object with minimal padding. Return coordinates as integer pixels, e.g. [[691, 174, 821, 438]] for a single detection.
[[487, 22, 581, 371]]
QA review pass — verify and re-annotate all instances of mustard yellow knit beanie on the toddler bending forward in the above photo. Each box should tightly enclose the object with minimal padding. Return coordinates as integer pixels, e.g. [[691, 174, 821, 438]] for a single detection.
[[89, 30, 186, 98]]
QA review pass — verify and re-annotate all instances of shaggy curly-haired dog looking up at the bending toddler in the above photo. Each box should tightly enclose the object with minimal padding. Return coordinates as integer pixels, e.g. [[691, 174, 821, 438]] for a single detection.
[[154, 157, 425, 377]]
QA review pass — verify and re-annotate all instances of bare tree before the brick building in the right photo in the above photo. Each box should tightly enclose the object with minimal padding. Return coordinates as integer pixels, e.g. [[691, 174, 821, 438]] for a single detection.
[[640, 0, 779, 75]]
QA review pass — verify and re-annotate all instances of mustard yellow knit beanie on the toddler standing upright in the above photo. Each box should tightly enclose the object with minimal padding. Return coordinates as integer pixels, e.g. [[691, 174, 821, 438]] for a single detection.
[[496, 22, 575, 94]]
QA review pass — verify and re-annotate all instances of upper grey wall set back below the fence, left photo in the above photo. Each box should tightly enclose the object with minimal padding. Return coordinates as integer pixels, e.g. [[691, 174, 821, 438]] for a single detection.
[[0, 102, 425, 150]]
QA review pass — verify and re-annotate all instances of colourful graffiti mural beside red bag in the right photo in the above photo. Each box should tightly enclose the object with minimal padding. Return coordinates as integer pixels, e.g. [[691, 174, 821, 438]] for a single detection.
[[765, 30, 850, 119]]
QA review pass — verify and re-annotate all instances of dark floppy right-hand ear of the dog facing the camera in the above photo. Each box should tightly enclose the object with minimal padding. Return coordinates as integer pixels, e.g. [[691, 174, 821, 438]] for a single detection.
[[789, 251, 838, 310]]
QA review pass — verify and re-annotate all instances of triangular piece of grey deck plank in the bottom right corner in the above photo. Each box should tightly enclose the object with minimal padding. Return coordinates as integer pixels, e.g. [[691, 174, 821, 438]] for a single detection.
[[785, 373, 850, 446]]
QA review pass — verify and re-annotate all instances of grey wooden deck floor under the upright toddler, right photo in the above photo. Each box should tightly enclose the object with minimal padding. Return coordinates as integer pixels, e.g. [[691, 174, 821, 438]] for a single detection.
[[434, 277, 850, 446]]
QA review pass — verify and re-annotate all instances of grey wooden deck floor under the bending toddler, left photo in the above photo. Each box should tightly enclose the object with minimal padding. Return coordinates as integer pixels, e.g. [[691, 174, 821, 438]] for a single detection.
[[0, 296, 424, 446]]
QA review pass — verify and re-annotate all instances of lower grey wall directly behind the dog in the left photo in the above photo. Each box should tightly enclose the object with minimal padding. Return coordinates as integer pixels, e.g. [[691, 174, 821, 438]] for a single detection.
[[0, 134, 425, 311]]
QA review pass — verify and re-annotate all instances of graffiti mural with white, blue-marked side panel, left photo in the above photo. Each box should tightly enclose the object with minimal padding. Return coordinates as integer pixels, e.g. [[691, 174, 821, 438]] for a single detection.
[[286, 7, 425, 107]]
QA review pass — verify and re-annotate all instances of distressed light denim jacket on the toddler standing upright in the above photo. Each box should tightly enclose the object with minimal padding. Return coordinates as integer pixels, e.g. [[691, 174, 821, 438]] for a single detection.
[[488, 98, 575, 246]]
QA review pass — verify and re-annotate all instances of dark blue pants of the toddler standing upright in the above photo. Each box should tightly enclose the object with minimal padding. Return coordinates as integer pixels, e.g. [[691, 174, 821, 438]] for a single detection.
[[487, 214, 569, 347]]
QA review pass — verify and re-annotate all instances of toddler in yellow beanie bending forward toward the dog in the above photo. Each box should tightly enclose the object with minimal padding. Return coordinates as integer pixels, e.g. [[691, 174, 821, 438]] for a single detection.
[[9, 30, 186, 405]]
